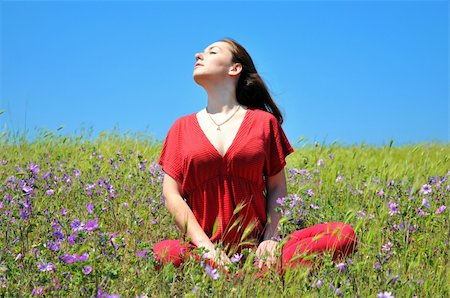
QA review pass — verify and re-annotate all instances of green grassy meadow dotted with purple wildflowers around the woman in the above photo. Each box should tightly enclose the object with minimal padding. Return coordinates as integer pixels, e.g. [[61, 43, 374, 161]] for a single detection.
[[0, 133, 450, 297]]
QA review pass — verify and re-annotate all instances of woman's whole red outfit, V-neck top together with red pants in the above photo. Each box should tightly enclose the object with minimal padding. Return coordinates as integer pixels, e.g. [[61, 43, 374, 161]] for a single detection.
[[154, 108, 357, 268]]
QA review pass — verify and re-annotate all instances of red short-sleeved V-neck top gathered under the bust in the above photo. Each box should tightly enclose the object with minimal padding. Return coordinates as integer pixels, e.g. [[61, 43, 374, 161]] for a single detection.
[[159, 108, 294, 249]]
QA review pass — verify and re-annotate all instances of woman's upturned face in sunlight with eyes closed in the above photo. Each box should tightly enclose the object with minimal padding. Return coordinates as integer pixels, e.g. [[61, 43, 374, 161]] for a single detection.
[[193, 41, 236, 85]]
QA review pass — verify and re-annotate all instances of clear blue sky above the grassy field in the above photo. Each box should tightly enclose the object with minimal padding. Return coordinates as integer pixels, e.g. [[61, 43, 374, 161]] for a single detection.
[[0, 1, 450, 146]]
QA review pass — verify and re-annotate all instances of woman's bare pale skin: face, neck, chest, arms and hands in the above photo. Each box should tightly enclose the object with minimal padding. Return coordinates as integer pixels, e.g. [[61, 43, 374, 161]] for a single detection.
[[163, 42, 287, 268]]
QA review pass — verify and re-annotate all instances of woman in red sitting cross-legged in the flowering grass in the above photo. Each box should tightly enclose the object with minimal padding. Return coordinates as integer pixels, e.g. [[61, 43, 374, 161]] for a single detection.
[[154, 39, 356, 267]]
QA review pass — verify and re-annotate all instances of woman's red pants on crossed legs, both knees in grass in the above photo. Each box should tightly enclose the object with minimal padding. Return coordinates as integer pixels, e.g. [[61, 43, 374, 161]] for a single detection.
[[153, 222, 357, 268]]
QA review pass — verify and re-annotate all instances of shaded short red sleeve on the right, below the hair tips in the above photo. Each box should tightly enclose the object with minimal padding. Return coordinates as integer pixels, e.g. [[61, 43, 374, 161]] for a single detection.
[[264, 117, 294, 177]]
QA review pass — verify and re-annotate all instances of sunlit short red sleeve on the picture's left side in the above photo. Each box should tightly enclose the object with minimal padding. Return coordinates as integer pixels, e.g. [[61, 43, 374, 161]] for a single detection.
[[158, 120, 183, 185]]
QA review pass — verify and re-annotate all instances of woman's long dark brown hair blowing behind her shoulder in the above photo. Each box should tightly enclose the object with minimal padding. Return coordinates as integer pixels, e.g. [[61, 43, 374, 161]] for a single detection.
[[221, 38, 283, 124]]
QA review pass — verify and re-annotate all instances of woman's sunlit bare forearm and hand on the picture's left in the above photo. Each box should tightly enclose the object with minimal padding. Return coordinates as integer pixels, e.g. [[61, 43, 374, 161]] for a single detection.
[[163, 174, 230, 263]]
